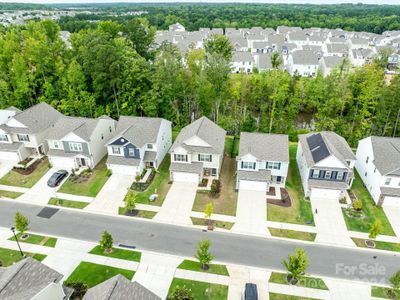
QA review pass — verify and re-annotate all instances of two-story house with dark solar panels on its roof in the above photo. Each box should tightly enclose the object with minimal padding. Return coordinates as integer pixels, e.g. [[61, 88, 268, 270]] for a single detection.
[[296, 131, 356, 199]]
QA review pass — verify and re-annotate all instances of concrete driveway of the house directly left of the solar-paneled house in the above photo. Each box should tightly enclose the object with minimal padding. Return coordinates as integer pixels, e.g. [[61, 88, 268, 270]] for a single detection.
[[232, 190, 270, 236]]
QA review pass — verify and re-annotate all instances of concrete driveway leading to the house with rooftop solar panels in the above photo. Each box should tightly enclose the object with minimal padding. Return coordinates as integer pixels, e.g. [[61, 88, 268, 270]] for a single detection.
[[311, 197, 355, 247]]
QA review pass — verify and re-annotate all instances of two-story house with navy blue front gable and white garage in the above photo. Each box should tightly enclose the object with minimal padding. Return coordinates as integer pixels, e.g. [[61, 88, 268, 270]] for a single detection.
[[107, 116, 172, 176]]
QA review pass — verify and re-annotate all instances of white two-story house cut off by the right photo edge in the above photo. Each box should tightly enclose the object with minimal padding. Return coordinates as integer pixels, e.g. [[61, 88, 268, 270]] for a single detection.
[[356, 136, 400, 207]]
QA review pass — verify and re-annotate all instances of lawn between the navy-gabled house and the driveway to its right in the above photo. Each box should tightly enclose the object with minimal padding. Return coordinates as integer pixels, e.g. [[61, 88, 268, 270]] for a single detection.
[[135, 155, 171, 206]]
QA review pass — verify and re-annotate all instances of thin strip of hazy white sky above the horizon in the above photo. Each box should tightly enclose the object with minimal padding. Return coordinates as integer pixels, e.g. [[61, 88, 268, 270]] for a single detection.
[[0, 0, 400, 5]]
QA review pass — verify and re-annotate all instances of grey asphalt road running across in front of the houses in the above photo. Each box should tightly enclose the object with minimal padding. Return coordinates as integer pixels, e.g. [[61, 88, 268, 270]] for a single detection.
[[0, 200, 400, 282]]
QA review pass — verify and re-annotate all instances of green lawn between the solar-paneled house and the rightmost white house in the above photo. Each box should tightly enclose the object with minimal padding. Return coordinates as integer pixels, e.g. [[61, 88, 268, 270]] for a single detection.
[[343, 172, 395, 236]]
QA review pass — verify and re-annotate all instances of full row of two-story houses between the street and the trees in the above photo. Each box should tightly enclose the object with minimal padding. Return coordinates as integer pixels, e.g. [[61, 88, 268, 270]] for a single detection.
[[0, 103, 400, 206]]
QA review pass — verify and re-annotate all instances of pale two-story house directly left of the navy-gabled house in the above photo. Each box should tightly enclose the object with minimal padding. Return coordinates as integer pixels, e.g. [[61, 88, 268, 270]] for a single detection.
[[47, 116, 116, 170]]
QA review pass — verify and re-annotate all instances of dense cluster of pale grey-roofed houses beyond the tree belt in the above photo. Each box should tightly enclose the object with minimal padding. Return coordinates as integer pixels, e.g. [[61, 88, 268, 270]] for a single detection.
[[155, 23, 400, 77]]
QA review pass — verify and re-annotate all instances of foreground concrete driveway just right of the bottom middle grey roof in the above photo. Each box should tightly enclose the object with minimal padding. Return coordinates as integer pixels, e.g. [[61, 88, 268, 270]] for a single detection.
[[132, 253, 183, 299]]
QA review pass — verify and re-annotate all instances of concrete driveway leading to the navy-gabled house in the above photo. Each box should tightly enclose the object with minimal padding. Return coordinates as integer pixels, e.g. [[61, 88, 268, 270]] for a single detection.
[[85, 174, 135, 215]]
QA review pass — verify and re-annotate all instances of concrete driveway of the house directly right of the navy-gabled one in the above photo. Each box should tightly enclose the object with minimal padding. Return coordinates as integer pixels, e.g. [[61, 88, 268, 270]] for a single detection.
[[154, 182, 197, 225]]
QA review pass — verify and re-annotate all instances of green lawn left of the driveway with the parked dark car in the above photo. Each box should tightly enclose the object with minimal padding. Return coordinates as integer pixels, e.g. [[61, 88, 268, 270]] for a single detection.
[[0, 158, 50, 188]]
